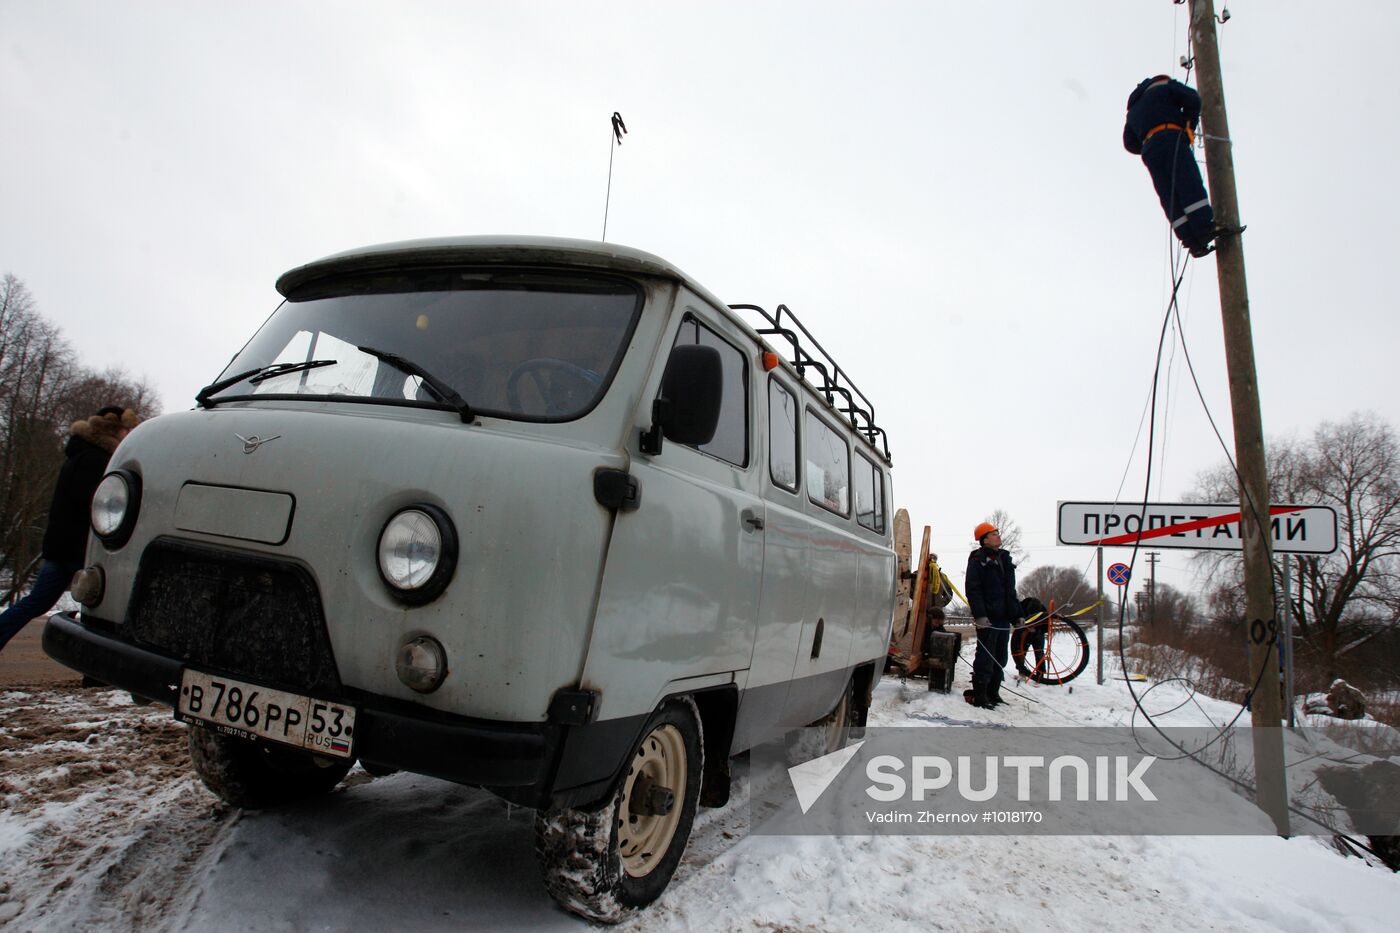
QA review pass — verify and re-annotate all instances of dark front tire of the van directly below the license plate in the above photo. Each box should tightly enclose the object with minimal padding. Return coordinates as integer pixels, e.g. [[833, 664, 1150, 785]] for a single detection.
[[189, 726, 354, 810]]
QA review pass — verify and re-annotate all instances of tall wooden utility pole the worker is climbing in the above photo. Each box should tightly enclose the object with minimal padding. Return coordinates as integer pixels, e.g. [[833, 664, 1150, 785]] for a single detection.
[[1191, 0, 1288, 835]]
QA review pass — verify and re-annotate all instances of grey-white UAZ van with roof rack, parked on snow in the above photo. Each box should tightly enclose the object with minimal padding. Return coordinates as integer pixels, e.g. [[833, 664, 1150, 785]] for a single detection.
[[45, 237, 895, 920]]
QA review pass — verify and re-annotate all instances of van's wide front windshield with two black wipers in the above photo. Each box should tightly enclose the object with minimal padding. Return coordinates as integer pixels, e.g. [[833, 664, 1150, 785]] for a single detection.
[[210, 264, 641, 422]]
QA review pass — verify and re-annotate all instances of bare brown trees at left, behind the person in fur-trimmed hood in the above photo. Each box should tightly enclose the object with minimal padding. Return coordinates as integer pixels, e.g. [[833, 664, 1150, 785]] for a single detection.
[[0, 275, 160, 604]]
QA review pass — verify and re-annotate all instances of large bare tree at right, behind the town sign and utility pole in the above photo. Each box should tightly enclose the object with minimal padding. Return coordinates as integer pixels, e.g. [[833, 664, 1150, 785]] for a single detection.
[[1196, 413, 1400, 677]]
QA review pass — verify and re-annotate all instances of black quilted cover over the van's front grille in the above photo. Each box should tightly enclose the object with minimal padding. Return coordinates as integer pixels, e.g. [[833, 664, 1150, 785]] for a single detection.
[[127, 541, 340, 693]]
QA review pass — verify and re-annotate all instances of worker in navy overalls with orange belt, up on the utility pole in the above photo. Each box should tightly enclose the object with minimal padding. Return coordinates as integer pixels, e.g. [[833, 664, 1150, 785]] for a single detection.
[[1123, 74, 1222, 256]]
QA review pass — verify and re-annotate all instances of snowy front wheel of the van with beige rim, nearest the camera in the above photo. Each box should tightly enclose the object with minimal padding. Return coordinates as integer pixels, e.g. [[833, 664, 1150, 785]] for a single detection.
[[535, 696, 704, 923]]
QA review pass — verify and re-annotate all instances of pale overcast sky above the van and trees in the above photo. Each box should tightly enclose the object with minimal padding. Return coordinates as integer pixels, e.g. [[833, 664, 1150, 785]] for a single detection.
[[0, 0, 1400, 596]]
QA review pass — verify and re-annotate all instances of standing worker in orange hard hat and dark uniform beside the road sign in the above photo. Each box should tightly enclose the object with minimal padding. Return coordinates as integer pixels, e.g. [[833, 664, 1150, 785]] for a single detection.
[[966, 521, 1021, 709]]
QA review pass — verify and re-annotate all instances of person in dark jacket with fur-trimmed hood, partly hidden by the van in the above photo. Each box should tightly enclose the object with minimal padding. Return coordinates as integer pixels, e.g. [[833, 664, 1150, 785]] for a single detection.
[[0, 406, 139, 649]]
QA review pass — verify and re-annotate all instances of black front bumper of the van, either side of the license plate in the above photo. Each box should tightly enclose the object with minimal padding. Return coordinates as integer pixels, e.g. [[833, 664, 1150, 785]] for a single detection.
[[43, 612, 566, 790]]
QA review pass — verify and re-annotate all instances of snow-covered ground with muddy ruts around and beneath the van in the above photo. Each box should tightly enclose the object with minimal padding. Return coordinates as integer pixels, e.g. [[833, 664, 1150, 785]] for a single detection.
[[0, 652, 1400, 933]]
